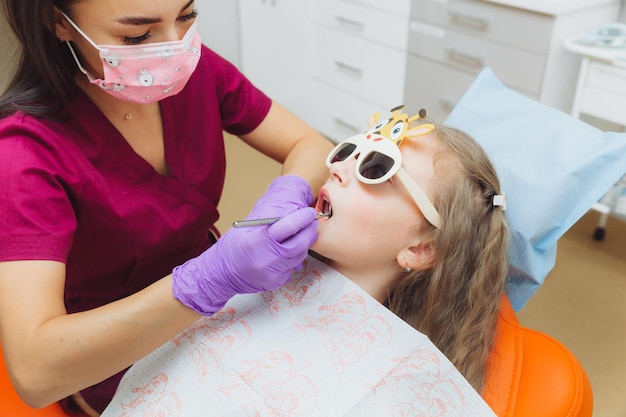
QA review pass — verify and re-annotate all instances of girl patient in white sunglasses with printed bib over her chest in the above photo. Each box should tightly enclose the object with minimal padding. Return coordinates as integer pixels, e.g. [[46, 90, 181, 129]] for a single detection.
[[106, 109, 508, 416]]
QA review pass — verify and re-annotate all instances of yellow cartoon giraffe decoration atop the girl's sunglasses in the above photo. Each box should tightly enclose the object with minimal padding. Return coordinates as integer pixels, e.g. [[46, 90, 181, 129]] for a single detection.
[[365, 105, 435, 146]]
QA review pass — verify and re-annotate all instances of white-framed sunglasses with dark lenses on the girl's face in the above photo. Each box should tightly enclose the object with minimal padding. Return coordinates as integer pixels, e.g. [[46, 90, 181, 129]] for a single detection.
[[326, 133, 441, 229]]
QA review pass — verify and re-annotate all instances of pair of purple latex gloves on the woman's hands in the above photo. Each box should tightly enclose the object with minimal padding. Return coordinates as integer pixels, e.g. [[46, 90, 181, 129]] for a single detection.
[[172, 176, 317, 315]]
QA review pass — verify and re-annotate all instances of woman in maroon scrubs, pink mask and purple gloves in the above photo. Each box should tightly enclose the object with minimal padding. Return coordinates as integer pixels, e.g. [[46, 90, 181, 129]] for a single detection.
[[0, 0, 332, 414]]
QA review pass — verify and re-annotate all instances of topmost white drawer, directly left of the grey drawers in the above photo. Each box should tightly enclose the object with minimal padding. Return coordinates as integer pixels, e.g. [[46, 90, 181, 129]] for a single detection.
[[316, 0, 409, 50]]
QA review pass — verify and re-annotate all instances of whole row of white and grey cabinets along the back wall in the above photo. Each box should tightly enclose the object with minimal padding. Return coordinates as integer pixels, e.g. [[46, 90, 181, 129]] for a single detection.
[[239, 0, 620, 141]]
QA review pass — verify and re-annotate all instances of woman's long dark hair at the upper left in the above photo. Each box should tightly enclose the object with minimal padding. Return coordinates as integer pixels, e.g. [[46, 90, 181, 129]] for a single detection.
[[0, 0, 77, 118]]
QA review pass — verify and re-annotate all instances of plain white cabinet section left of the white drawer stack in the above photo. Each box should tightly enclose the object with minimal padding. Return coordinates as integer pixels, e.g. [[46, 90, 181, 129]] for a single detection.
[[239, 0, 315, 121]]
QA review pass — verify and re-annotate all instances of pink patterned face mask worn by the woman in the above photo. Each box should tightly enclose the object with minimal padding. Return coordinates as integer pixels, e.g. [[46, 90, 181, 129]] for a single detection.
[[61, 12, 201, 104]]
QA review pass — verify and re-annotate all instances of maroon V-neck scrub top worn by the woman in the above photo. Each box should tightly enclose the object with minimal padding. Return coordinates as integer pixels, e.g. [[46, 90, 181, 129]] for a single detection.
[[0, 47, 271, 411]]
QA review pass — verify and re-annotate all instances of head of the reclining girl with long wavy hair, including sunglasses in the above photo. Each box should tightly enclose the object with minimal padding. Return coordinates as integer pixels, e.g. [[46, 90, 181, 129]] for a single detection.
[[312, 110, 508, 392]]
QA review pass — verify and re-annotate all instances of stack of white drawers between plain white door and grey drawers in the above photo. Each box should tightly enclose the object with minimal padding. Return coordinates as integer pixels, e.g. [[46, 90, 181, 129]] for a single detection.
[[307, 0, 410, 141]]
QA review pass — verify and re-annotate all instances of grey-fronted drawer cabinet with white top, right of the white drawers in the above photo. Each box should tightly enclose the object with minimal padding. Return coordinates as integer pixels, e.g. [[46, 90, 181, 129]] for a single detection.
[[406, 0, 619, 120]]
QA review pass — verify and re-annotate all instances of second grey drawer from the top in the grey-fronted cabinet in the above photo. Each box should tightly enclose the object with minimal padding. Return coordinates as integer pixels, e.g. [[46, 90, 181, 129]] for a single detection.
[[409, 22, 546, 96]]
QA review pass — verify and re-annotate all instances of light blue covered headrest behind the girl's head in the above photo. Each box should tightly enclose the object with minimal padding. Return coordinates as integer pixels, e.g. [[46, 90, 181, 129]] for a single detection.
[[446, 68, 626, 311]]
